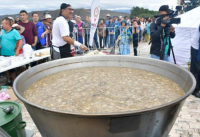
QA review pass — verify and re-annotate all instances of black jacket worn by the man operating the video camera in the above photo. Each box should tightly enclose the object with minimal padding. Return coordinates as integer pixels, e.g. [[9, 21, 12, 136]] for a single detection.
[[150, 23, 176, 57]]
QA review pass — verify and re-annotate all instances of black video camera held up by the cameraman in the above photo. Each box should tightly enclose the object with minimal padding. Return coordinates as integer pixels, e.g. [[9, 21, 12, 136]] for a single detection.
[[154, 6, 182, 25]]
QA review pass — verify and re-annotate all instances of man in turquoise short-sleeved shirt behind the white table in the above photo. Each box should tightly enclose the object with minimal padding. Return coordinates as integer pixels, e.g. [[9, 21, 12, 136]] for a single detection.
[[0, 18, 23, 85]]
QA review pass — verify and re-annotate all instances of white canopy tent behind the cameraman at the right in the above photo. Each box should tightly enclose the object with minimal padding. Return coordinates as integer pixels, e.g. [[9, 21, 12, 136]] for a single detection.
[[171, 7, 200, 67]]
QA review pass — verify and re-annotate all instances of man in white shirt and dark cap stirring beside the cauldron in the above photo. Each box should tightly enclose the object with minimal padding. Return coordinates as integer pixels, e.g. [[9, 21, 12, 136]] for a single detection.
[[51, 3, 87, 60]]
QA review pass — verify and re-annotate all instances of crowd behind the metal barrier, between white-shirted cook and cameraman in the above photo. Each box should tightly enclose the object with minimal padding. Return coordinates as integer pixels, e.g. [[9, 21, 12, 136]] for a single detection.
[[71, 14, 153, 56]]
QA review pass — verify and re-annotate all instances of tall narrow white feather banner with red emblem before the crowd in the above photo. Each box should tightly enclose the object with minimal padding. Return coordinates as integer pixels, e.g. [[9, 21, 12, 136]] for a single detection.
[[90, 0, 100, 46]]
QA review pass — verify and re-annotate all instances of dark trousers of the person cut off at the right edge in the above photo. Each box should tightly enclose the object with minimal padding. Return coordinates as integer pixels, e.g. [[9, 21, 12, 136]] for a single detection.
[[190, 47, 200, 93]]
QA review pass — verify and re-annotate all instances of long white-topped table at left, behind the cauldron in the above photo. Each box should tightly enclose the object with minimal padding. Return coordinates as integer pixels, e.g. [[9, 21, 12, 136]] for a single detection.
[[0, 48, 50, 73]]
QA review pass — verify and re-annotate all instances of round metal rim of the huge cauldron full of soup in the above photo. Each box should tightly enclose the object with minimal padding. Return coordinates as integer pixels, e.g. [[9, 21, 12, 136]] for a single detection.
[[13, 55, 196, 117]]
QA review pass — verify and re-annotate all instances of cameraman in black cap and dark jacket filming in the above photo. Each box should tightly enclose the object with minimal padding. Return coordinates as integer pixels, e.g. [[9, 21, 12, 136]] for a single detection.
[[150, 5, 175, 62]]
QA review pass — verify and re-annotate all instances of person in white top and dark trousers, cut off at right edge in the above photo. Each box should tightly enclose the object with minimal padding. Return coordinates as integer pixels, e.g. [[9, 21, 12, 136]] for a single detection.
[[190, 26, 200, 98]]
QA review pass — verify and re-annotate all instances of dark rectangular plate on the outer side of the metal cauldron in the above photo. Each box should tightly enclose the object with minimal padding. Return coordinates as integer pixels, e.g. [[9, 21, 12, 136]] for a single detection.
[[110, 115, 141, 133]]
